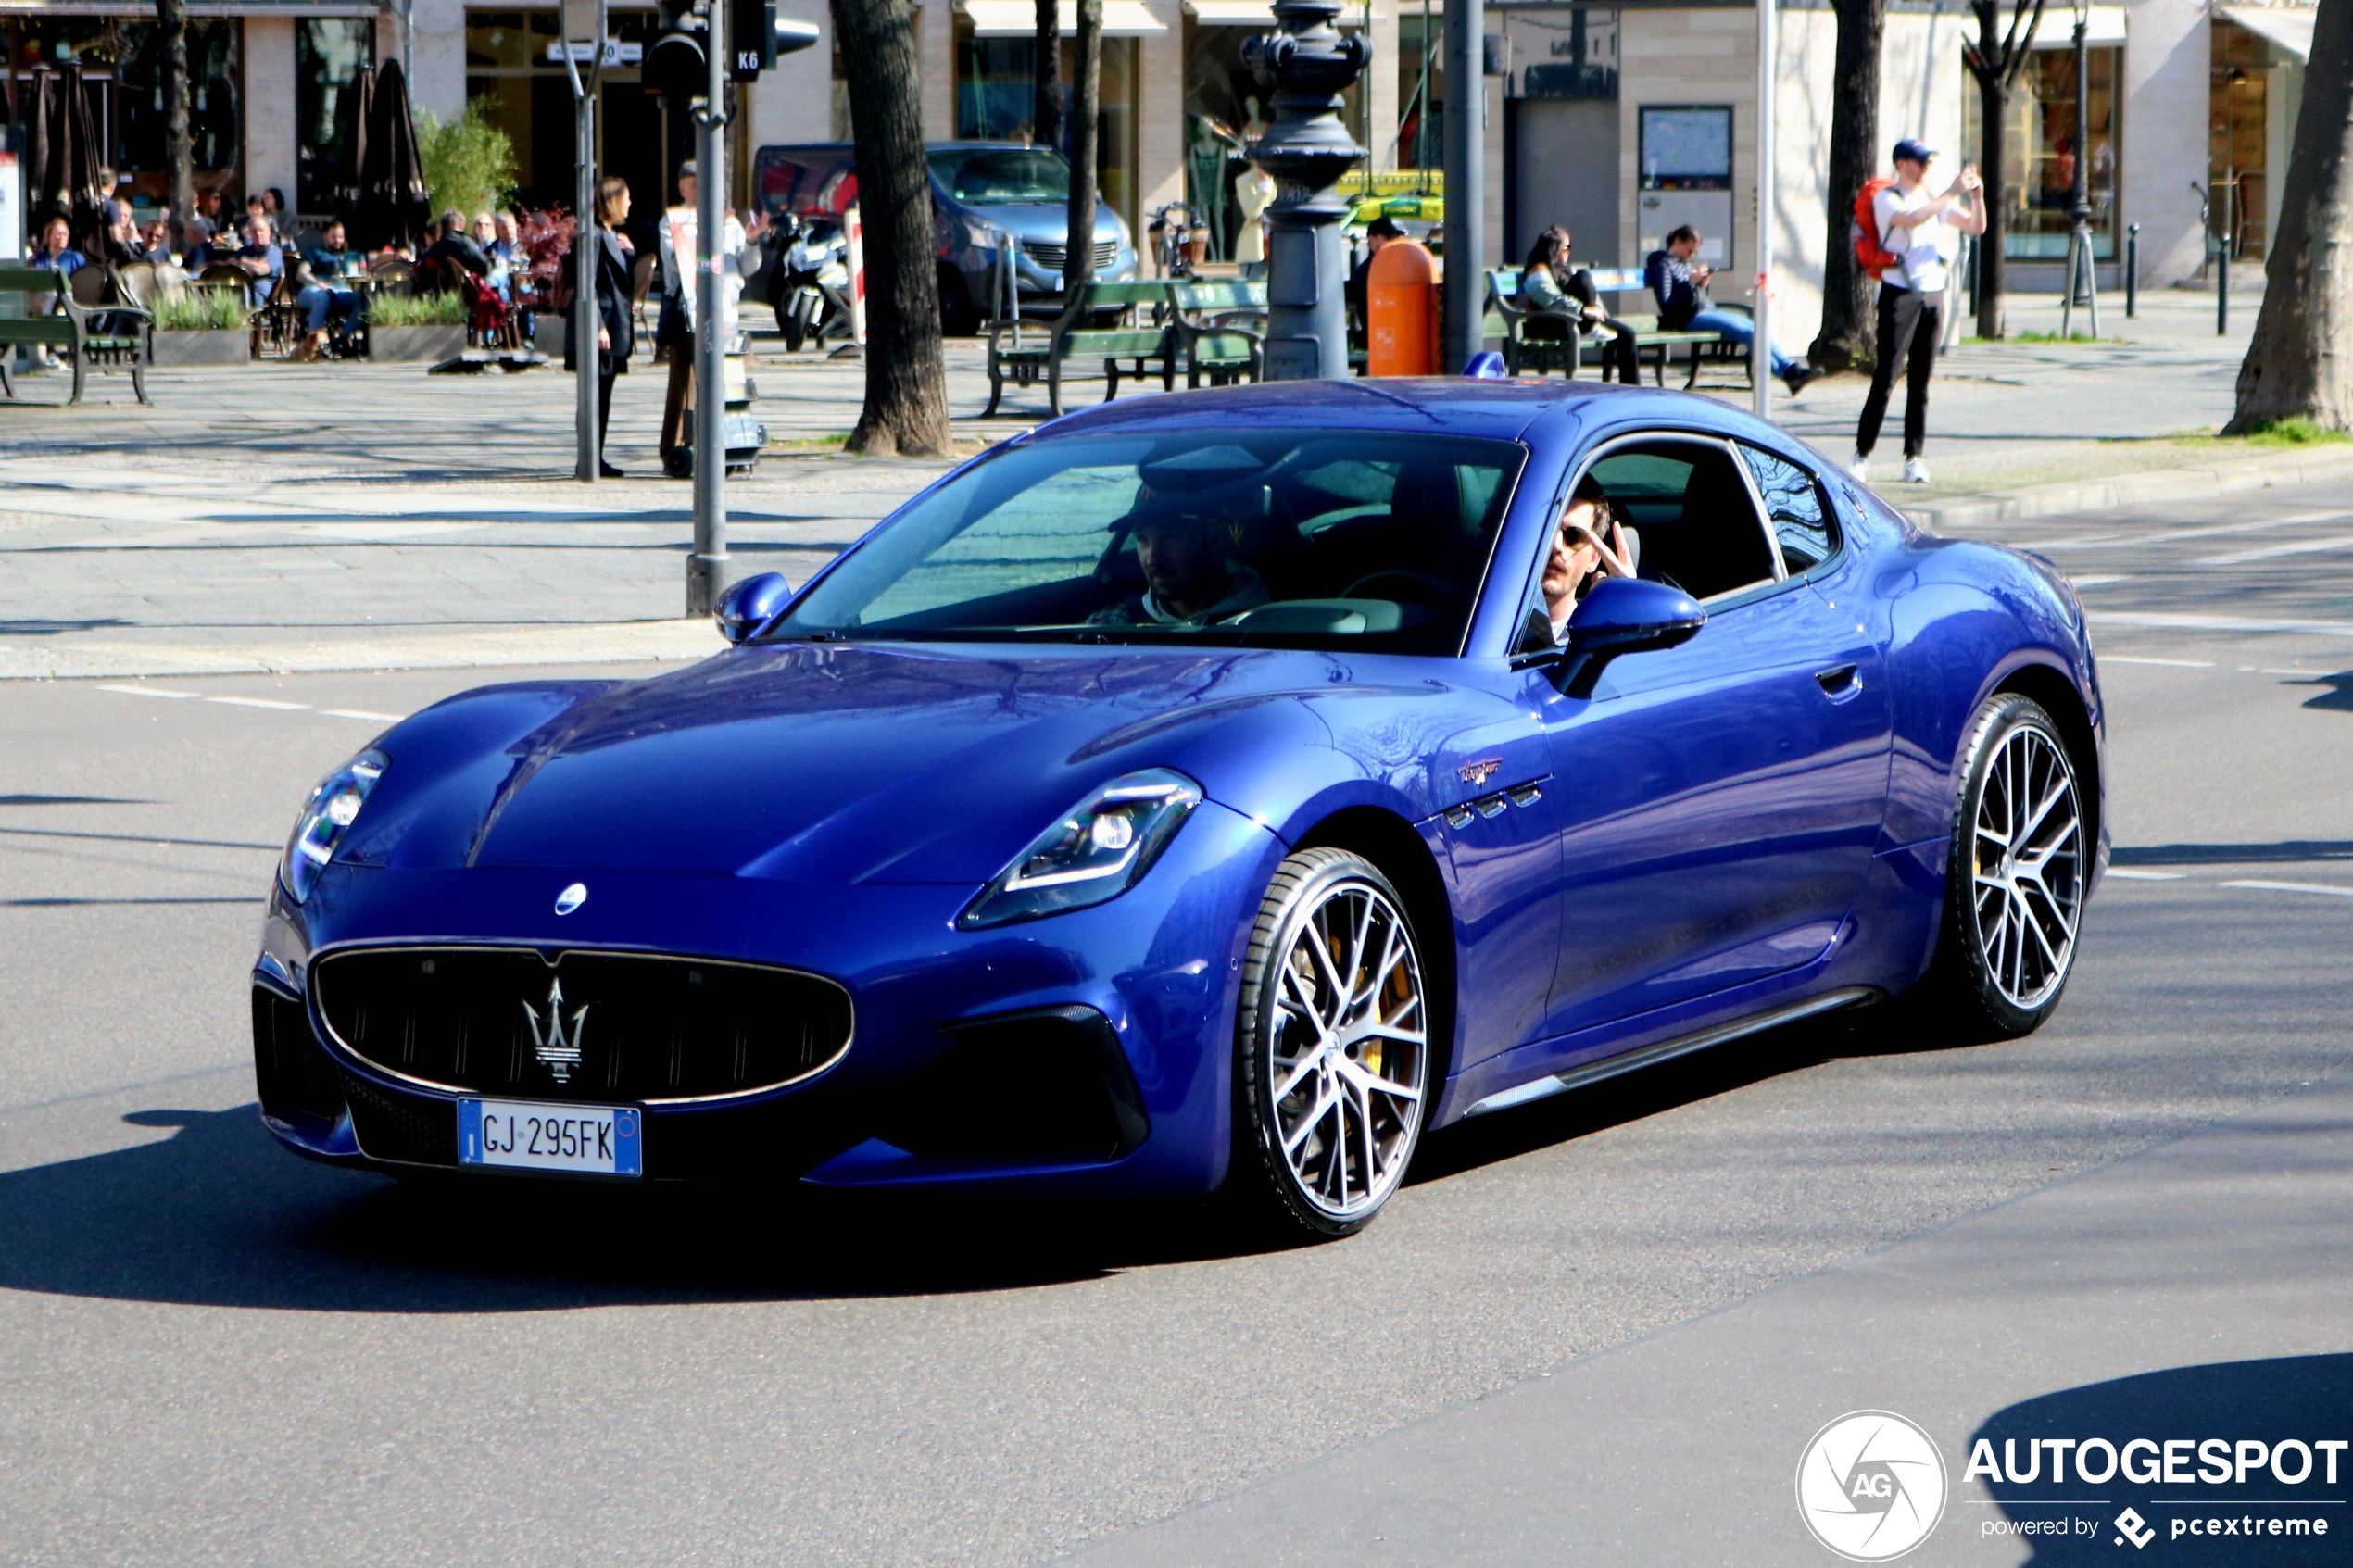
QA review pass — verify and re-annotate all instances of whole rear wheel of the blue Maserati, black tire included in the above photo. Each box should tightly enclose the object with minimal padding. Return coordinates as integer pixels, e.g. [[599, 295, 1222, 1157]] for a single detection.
[[1922, 691, 2092, 1039]]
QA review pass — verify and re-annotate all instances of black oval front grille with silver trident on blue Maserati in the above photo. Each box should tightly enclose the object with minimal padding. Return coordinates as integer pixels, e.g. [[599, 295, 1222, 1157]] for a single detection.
[[310, 947, 851, 1102]]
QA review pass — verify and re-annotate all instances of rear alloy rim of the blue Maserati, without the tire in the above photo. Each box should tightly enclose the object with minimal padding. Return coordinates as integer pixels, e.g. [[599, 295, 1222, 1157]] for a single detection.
[[1969, 724, 2084, 1010]]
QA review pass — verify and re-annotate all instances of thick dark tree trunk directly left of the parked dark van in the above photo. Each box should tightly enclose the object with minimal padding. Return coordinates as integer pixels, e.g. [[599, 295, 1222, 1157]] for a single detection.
[[833, 0, 949, 456]]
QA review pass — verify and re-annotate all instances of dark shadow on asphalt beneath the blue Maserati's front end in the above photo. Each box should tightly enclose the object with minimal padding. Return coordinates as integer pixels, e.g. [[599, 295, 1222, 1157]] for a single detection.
[[0, 1105, 1308, 1311]]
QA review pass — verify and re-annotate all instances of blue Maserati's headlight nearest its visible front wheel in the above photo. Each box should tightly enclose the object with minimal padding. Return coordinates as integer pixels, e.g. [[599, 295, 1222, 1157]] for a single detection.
[[955, 769, 1200, 931]]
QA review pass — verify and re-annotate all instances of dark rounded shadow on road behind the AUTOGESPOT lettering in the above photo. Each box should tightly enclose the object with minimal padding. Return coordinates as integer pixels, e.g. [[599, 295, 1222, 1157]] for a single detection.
[[1969, 1354, 2353, 1568]]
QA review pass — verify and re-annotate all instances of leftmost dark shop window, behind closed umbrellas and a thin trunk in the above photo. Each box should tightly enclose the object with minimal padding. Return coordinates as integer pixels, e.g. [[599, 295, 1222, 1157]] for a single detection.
[[0, 17, 245, 207]]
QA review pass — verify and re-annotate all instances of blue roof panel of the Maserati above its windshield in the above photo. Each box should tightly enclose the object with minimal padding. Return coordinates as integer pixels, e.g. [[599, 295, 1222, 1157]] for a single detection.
[[1038, 376, 1739, 440]]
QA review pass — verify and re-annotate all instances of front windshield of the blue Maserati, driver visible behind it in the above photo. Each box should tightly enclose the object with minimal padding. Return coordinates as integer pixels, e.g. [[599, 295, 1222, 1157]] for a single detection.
[[770, 430, 1527, 654]]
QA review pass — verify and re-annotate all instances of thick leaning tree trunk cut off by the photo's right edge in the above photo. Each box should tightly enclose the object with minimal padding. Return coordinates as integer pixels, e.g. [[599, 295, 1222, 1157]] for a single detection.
[[2223, 0, 2353, 435]]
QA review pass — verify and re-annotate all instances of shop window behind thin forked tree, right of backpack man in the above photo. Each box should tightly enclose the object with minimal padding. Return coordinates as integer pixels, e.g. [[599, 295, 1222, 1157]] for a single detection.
[[1962, 44, 2125, 261]]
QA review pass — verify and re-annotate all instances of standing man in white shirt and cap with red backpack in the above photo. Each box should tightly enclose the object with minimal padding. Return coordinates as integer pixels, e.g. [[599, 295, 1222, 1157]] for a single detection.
[[1847, 136, 1986, 484]]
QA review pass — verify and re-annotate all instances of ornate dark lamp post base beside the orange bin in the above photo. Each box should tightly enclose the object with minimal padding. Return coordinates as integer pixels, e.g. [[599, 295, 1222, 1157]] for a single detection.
[[1242, 0, 1372, 381]]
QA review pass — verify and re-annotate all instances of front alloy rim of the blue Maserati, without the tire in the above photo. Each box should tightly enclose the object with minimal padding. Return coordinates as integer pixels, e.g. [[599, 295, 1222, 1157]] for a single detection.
[[1266, 879, 1430, 1220]]
